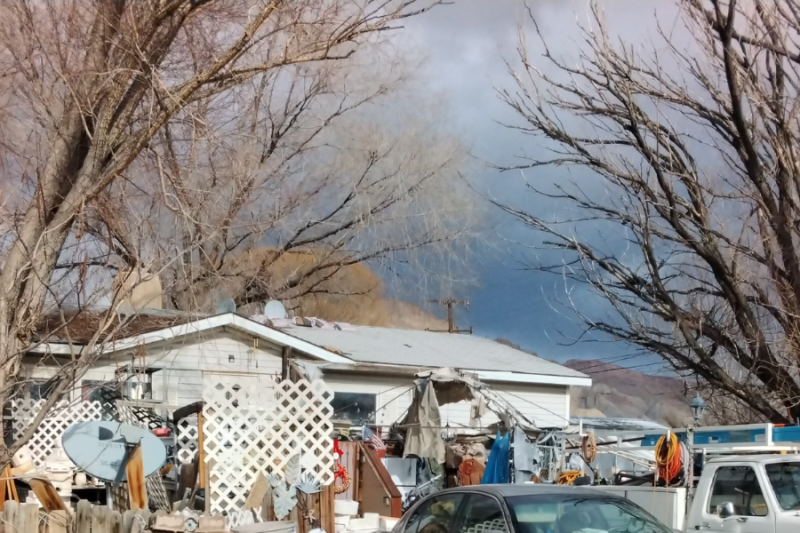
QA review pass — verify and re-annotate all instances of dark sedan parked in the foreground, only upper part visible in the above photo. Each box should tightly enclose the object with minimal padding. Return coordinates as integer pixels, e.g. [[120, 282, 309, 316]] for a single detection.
[[392, 485, 673, 533]]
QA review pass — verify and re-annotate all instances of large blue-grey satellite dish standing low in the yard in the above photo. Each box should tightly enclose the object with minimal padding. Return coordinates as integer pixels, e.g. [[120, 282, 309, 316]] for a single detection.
[[61, 420, 167, 483]]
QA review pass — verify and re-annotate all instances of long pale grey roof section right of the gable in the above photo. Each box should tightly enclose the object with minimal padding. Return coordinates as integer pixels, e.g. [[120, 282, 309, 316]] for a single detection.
[[282, 326, 591, 386]]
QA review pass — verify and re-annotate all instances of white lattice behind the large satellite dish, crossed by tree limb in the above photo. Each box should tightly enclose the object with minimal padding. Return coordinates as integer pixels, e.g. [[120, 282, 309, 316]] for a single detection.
[[11, 400, 113, 467]]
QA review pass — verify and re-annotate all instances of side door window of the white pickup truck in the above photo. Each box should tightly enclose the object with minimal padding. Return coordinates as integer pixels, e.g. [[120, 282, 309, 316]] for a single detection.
[[708, 466, 767, 516]]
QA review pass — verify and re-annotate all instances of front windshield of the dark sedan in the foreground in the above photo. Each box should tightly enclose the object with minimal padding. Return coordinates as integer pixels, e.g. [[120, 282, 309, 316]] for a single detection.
[[506, 494, 672, 533]]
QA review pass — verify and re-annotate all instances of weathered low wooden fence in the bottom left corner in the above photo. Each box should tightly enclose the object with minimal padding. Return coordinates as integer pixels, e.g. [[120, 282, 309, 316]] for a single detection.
[[0, 500, 156, 533]]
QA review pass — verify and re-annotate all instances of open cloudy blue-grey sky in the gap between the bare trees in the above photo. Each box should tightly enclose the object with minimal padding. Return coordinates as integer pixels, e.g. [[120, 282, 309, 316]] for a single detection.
[[392, 0, 676, 372]]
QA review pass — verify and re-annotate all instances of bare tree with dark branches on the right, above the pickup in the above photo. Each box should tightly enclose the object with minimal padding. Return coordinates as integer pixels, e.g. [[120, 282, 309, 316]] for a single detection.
[[495, 0, 800, 422]]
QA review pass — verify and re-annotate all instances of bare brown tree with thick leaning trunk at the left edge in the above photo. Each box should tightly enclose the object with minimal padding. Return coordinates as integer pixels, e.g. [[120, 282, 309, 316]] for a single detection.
[[0, 0, 450, 463]]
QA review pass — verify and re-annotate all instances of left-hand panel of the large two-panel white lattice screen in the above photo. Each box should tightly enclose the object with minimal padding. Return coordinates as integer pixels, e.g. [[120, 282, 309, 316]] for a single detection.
[[203, 374, 274, 514]]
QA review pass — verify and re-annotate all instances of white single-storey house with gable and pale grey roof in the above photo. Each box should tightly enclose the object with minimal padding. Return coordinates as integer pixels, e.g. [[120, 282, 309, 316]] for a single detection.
[[25, 311, 591, 428]]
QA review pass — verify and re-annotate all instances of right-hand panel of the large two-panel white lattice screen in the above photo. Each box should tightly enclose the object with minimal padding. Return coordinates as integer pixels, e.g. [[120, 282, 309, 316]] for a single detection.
[[266, 379, 334, 485]]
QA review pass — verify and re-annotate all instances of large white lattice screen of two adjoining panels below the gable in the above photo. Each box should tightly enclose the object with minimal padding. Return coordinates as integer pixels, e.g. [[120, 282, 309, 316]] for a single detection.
[[203, 374, 334, 514]]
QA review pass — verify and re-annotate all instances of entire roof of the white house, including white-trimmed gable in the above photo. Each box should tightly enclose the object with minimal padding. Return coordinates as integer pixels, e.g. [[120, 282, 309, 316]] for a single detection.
[[30, 311, 591, 386]]
